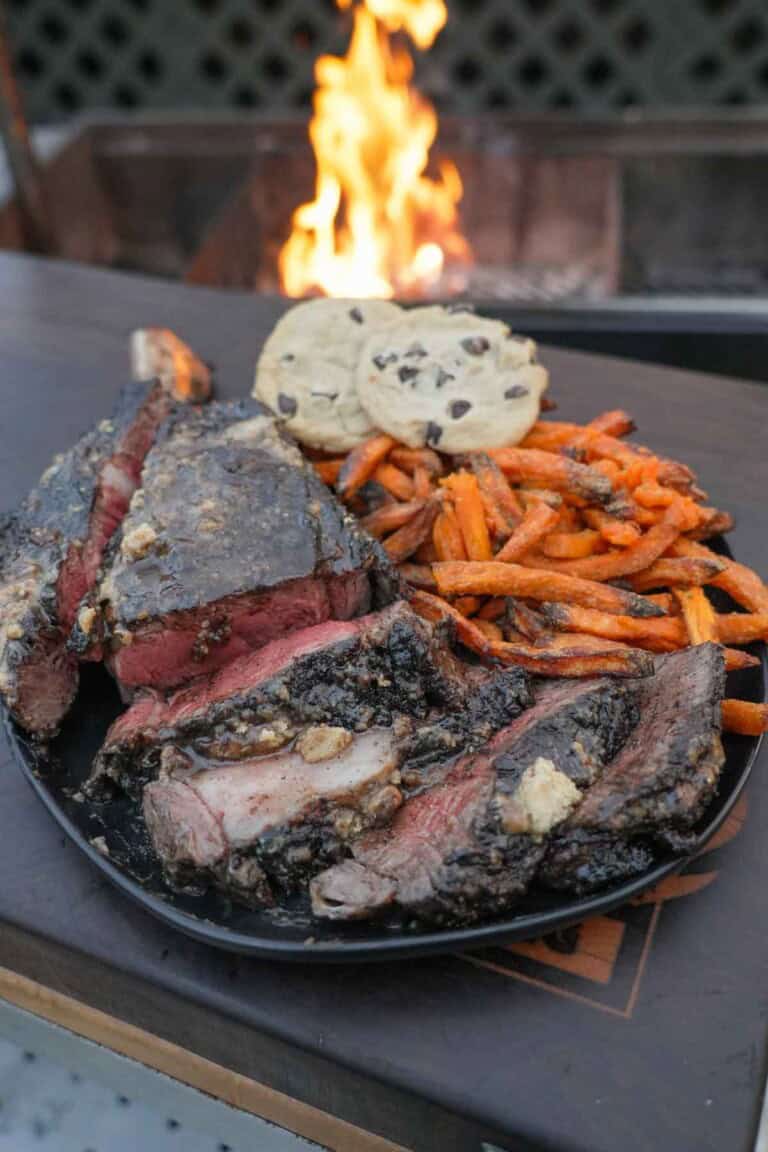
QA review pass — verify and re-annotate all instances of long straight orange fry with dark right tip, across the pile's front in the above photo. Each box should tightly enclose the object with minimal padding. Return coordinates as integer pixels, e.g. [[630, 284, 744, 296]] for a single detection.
[[433, 561, 663, 616]]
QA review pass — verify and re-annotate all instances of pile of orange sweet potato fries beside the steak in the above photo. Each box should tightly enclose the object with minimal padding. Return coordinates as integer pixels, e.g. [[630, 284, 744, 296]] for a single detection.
[[313, 411, 768, 735]]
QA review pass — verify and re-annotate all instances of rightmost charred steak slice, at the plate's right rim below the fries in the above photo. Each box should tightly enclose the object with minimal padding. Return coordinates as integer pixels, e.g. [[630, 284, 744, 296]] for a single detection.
[[541, 644, 725, 893]]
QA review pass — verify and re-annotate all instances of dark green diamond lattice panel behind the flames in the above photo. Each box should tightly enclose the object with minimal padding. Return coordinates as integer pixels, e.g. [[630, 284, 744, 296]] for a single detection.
[[6, 0, 768, 121]]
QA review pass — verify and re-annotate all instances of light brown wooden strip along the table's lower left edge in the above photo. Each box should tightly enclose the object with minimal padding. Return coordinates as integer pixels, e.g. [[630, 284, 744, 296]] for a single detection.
[[0, 967, 408, 1152]]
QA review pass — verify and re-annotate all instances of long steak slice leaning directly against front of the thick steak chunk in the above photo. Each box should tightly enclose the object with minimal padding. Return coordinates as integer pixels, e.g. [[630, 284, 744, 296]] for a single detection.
[[94, 601, 532, 785]]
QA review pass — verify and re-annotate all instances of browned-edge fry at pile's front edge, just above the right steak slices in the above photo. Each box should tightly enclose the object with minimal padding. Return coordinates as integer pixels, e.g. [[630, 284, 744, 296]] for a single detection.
[[489, 635, 653, 677]]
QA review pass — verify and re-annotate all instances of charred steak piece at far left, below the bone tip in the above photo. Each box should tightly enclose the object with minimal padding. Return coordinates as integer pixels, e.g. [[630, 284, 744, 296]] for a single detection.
[[0, 384, 172, 737]]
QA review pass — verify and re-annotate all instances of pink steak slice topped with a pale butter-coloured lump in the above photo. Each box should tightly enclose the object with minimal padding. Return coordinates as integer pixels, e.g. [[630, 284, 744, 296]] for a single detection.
[[311, 680, 638, 924]]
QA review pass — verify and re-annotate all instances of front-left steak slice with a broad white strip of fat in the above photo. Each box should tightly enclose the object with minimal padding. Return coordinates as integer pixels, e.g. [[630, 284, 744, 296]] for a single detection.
[[144, 726, 402, 905]]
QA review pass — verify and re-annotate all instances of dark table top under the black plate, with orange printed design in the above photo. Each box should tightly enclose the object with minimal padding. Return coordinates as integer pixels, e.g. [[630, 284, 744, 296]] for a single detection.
[[0, 256, 768, 1152]]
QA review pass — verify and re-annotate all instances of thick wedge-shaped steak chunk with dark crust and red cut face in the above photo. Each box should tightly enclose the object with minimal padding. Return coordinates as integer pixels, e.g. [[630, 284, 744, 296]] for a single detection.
[[91, 401, 396, 689]]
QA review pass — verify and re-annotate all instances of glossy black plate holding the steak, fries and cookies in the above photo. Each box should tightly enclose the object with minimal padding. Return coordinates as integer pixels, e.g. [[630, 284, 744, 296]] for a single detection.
[[6, 562, 766, 962]]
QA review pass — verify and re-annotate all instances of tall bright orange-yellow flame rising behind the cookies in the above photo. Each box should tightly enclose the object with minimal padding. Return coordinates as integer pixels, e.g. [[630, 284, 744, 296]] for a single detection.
[[280, 0, 470, 297]]
